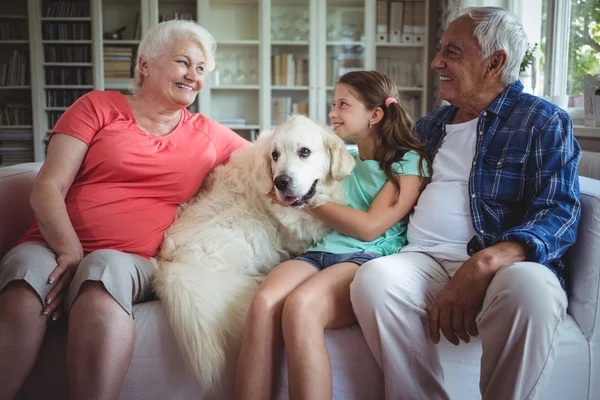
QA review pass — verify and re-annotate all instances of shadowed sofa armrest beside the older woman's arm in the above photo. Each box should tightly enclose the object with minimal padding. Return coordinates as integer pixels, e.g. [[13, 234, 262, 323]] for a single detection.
[[0, 163, 42, 258]]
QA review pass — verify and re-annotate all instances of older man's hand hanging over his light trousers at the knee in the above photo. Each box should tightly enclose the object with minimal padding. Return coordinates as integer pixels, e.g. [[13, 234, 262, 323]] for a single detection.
[[429, 255, 495, 346]]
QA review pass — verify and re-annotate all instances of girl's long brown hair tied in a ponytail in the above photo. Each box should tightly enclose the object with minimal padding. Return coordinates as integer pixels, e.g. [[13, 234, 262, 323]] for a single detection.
[[338, 71, 432, 198]]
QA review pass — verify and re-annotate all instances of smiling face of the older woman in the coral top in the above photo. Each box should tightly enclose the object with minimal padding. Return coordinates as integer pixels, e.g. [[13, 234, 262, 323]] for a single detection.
[[140, 39, 205, 108]]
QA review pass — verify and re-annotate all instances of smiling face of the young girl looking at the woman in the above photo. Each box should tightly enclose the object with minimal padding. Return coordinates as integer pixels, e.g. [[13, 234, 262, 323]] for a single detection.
[[329, 83, 372, 142]]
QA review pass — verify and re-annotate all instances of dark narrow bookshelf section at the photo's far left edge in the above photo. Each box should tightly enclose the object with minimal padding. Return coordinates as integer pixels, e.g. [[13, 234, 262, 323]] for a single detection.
[[0, 2, 34, 166]]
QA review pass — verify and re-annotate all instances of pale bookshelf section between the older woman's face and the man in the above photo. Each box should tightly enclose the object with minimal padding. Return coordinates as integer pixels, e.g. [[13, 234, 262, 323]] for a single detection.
[[198, 0, 429, 138]]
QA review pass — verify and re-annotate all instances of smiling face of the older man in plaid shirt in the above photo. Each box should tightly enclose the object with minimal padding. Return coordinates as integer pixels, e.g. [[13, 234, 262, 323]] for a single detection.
[[431, 15, 487, 107]]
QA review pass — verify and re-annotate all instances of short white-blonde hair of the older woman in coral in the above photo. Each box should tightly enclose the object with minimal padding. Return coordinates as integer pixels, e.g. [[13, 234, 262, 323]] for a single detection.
[[130, 20, 217, 94]]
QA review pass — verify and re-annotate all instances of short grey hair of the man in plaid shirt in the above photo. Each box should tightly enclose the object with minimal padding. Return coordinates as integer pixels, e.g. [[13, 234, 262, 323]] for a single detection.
[[460, 7, 529, 85]]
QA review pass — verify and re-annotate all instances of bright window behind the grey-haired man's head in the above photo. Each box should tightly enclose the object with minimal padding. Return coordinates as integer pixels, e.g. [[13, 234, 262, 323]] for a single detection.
[[513, 0, 600, 124]]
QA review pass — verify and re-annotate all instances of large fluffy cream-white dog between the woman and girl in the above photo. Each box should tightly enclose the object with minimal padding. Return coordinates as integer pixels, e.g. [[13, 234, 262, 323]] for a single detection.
[[154, 116, 354, 390]]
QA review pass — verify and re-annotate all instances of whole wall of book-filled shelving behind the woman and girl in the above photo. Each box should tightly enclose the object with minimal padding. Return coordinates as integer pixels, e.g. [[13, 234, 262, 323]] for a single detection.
[[12, 0, 429, 162]]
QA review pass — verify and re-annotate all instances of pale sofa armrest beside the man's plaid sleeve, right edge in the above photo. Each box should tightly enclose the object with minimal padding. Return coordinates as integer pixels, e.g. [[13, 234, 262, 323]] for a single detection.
[[566, 177, 600, 342]]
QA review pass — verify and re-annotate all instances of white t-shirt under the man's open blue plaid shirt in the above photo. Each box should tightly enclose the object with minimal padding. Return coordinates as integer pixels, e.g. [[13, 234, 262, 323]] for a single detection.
[[402, 119, 478, 261]]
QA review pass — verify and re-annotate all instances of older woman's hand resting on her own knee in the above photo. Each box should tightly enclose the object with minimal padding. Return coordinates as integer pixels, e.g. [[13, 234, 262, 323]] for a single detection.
[[44, 247, 83, 321]]
